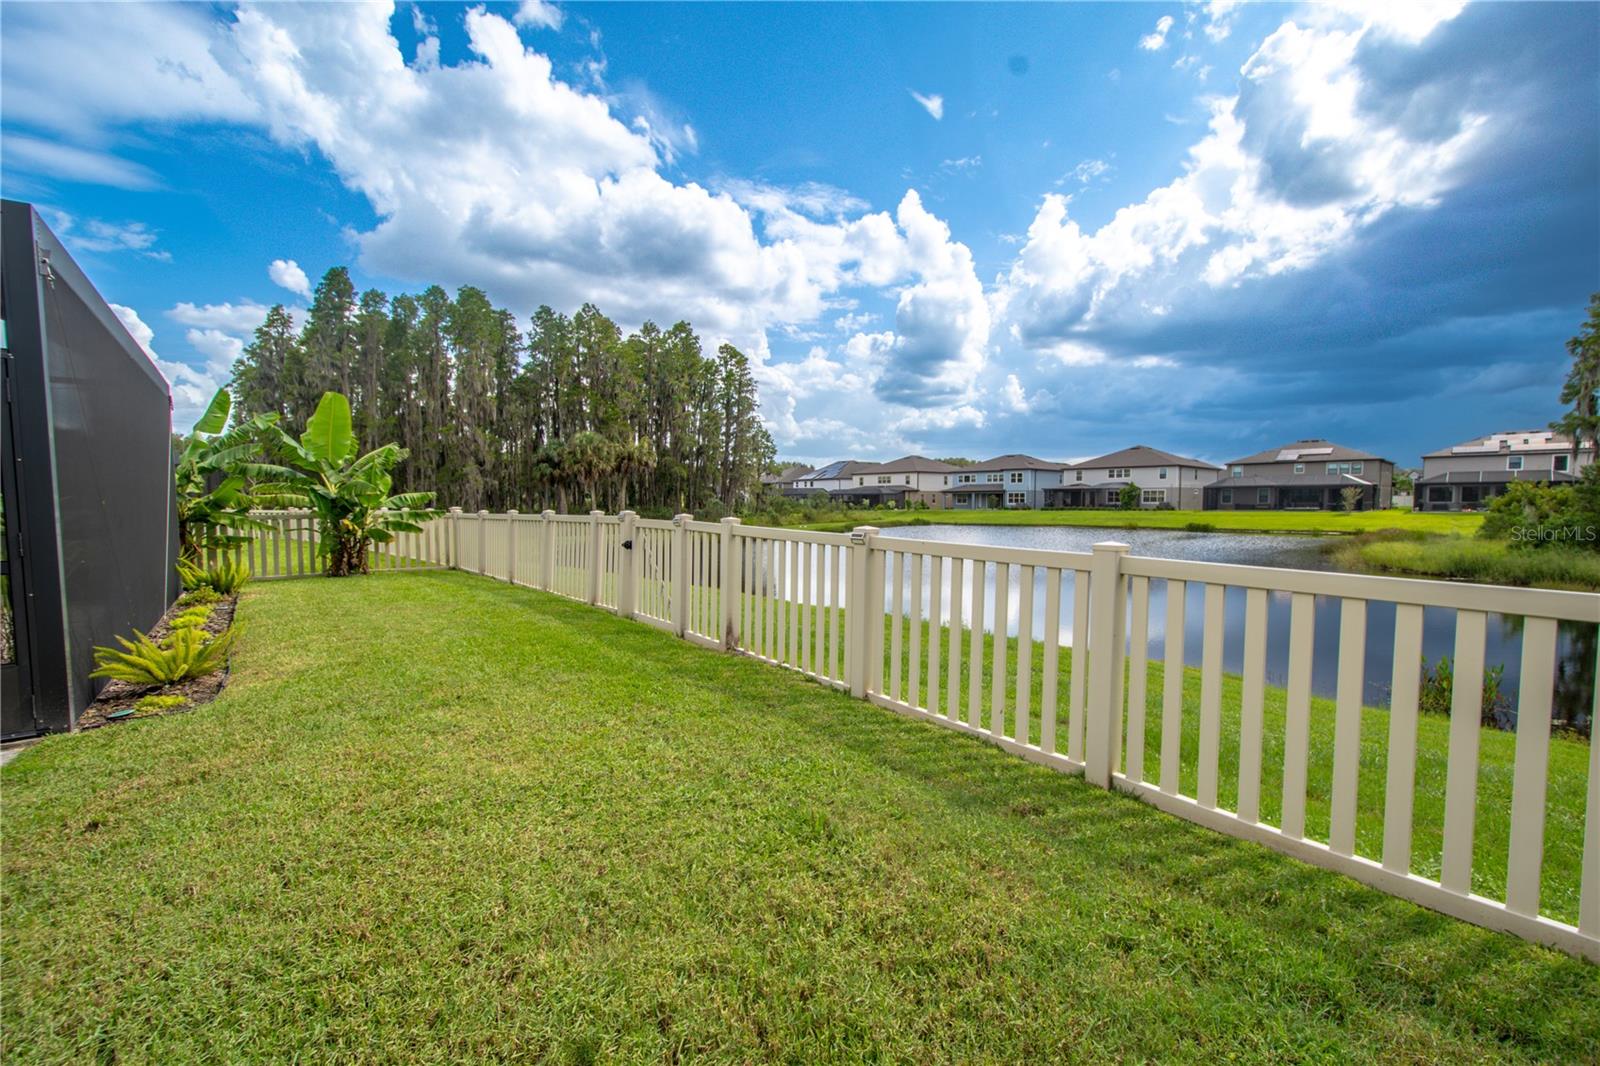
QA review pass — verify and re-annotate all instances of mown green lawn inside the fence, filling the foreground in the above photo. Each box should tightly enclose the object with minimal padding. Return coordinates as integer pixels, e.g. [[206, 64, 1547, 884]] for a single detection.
[[0, 573, 1600, 1063]]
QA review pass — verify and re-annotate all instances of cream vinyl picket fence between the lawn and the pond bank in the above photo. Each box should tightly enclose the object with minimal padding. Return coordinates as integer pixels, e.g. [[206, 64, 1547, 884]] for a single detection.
[[243, 509, 1600, 960]]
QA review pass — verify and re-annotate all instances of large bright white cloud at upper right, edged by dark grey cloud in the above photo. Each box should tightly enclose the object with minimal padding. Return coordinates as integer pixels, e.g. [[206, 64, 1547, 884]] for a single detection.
[[995, 2, 1483, 347]]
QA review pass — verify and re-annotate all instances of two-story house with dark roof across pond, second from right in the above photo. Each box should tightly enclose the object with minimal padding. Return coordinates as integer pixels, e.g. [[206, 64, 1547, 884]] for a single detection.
[[1205, 439, 1395, 511]]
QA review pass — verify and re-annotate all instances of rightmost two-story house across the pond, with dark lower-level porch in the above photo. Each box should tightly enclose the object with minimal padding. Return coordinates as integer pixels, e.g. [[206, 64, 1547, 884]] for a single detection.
[[1413, 429, 1595, 511]]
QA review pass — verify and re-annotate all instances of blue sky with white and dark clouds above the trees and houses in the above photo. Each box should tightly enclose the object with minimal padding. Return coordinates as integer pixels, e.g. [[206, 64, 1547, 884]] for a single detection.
[[0, 2, 1600, 463]]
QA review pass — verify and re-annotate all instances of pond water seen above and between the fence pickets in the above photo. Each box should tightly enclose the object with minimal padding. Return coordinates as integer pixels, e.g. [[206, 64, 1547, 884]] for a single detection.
[[882, 525, 1597, 733]]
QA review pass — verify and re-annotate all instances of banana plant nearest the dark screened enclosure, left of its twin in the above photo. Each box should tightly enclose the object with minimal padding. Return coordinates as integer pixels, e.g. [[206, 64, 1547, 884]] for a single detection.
[[173, 389, 278, 562]]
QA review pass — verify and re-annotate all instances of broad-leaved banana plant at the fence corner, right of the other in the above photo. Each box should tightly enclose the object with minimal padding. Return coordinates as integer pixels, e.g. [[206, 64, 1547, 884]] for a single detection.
[[245, 392, 438, 578]]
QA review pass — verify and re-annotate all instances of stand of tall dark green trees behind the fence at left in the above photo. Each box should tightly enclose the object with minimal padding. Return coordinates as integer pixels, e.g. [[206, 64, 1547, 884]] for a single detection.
[[230, 266, 774, 512]]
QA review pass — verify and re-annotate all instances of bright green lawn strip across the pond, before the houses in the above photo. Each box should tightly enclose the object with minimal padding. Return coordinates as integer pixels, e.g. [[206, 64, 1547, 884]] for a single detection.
[[746, 507, 1483, 536]]
